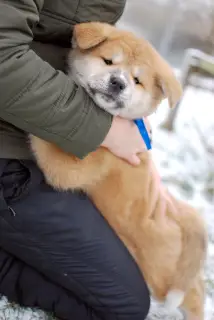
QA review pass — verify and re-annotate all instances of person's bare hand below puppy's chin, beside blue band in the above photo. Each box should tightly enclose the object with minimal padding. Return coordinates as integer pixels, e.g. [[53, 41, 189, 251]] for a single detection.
[[101, 117, 151, 166]]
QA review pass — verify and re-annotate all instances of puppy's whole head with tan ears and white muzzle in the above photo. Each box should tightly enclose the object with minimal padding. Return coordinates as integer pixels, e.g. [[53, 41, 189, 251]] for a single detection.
[[69, 22, 181, 119]]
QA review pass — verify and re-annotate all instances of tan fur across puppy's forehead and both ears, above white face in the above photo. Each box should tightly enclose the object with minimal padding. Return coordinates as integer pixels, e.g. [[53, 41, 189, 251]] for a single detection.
[[74, 22, 181, 107]]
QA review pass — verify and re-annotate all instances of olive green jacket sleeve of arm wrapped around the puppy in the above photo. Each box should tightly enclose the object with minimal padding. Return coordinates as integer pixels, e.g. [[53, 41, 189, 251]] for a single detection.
[[0, 0, 112, 158]]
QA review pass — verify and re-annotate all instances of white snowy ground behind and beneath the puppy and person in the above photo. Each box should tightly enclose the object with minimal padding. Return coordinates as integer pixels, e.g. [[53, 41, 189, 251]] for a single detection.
[[0, 89, 214, 320]]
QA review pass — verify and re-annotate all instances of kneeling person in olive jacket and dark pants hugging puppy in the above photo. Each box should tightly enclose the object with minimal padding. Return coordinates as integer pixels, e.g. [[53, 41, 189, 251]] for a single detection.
[[0, 0, 150, 320]]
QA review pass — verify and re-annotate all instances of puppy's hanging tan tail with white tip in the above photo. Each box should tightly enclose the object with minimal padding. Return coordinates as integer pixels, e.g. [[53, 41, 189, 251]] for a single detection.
[[165, 207, 207, 308]]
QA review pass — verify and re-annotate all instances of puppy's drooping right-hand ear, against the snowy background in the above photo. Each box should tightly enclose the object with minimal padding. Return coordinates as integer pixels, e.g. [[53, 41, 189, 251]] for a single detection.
[[156, 61, 182, 108]]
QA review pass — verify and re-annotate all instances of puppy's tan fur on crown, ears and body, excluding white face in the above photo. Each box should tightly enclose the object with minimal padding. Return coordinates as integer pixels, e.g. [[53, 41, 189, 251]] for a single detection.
[[31, 24, 207, 320]]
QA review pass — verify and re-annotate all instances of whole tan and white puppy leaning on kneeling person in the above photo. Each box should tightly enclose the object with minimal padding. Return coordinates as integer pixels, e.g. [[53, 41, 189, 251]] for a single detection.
[[31, 22, 207, 320]]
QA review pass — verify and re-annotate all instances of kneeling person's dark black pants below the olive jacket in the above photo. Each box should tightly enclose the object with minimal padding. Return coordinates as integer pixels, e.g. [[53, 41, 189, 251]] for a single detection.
[[0, 159, 150, 320]]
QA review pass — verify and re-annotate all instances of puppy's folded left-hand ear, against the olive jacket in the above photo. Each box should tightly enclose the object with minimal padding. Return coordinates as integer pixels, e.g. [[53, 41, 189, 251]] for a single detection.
[[73, 22, 114, 50]]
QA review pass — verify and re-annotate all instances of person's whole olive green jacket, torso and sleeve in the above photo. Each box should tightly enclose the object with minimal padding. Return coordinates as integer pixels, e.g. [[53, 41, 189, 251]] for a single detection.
[[0, 0, 125, 159]]
